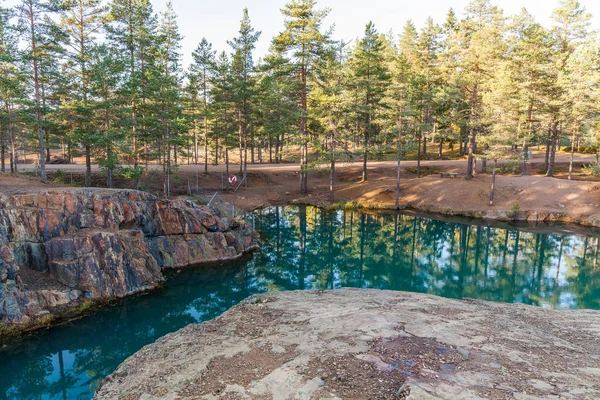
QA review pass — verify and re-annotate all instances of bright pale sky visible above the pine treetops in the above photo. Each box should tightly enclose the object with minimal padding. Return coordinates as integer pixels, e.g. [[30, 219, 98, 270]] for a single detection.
[[0, 0, 600, 66]]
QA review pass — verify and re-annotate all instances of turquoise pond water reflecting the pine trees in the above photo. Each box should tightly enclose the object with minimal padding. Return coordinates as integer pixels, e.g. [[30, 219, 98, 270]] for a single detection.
[[0, 207, 600, 399]]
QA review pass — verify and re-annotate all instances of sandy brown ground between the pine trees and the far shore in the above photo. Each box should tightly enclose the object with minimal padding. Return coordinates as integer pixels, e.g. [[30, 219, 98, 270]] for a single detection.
[[0, 152, 600, 223]]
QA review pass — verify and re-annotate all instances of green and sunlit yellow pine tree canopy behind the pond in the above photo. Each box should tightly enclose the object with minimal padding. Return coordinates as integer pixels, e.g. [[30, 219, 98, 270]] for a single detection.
[[0, 0, 600, 197]]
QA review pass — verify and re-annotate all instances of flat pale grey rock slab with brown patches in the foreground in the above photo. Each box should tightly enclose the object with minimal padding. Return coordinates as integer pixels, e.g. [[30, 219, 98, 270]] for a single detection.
[[95, 289, 600, 400]]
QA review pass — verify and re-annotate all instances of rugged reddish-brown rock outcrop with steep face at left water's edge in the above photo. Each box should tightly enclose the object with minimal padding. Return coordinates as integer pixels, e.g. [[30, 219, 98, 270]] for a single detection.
[[0, 190, 255, 325]]
